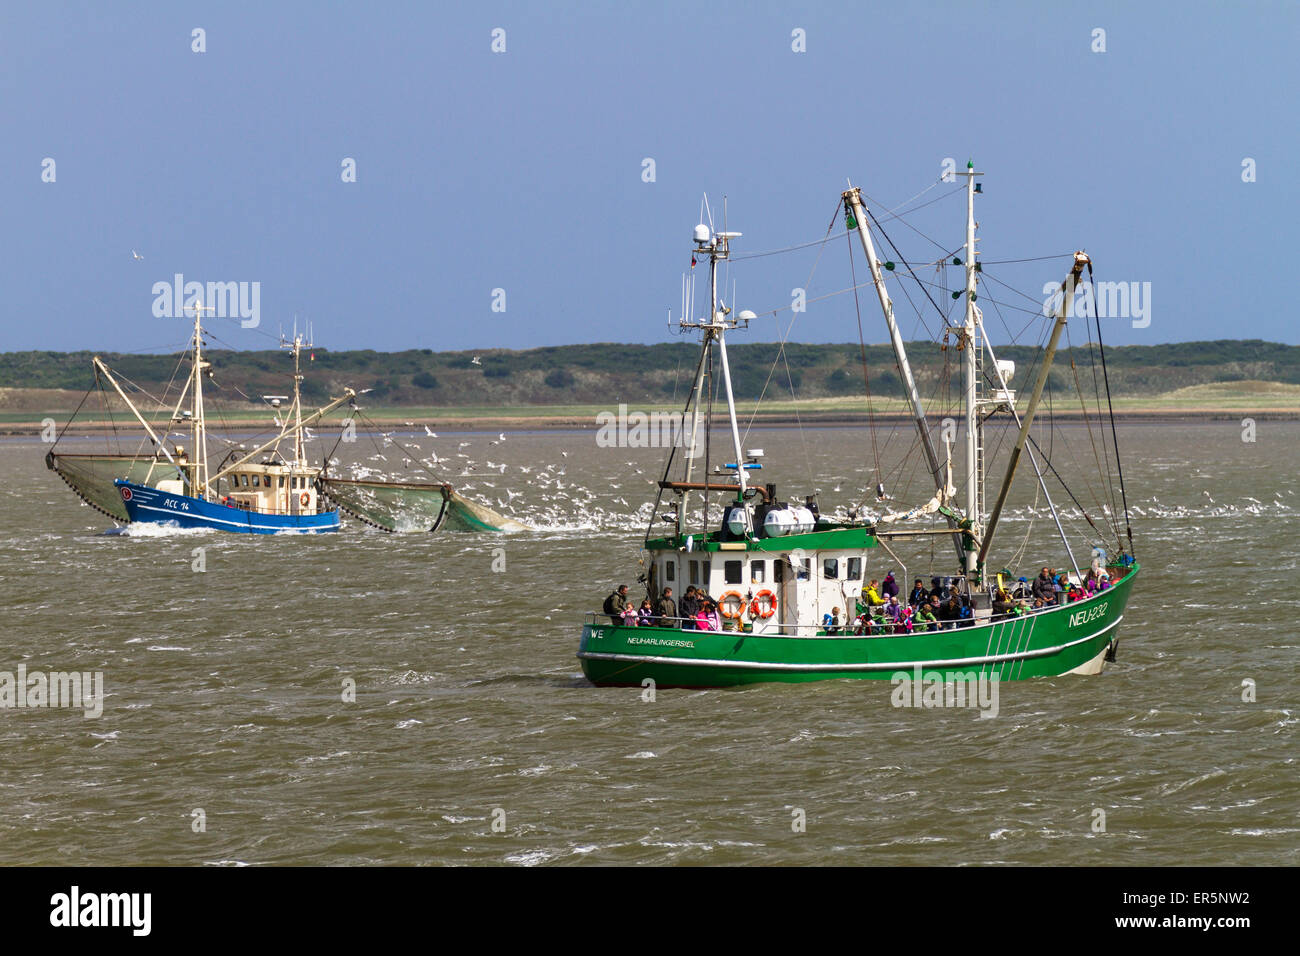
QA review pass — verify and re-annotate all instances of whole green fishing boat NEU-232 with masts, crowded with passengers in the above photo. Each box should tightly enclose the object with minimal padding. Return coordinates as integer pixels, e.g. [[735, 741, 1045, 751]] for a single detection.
[[577, 165, 1140, 687]]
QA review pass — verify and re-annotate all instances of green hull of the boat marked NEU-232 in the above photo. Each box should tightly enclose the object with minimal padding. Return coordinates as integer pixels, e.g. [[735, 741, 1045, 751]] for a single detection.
[[577, 564, 1139, 687]]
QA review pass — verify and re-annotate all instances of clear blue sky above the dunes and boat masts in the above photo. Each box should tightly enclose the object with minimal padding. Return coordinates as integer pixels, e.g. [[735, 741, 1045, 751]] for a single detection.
[[0, 1, 1300, 351]]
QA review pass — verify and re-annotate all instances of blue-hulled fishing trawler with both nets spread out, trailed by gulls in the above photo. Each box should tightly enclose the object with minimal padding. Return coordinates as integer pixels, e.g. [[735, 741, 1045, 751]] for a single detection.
[[46, 302, 525, 535]]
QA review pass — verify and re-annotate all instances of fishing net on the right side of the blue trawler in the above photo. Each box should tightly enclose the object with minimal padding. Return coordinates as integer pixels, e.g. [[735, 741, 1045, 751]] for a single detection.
[[319, 477, 528, 532]]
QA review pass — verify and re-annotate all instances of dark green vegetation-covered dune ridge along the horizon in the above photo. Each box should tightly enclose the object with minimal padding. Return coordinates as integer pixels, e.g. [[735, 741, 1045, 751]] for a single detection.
[[0, 339, 1300, 414]]
